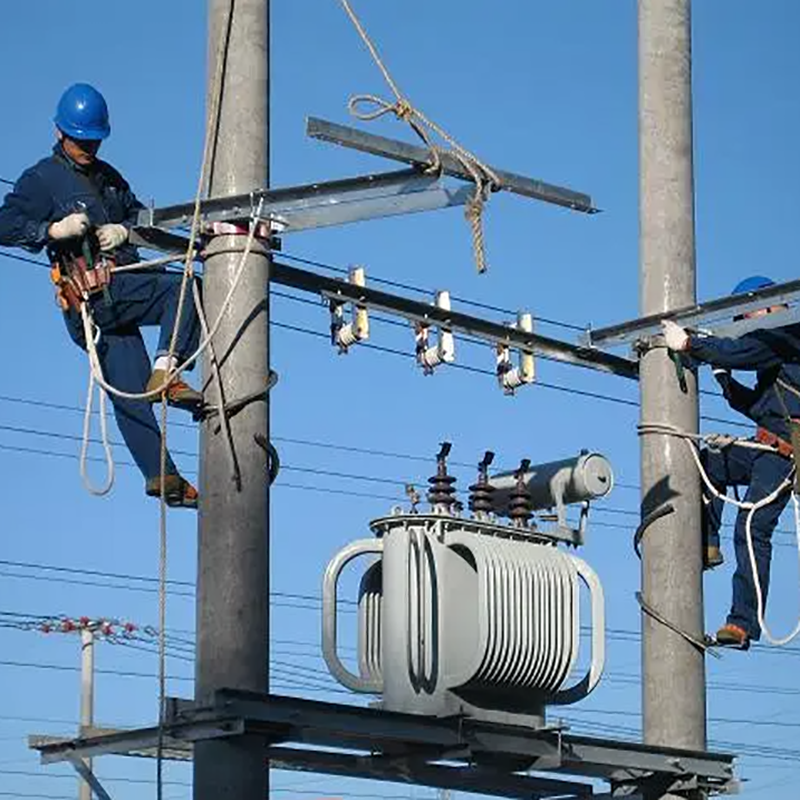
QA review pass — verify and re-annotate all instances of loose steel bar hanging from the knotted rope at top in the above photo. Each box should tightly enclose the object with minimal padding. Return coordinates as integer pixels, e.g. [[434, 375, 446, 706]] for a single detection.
[[306, 117, 597, 214]]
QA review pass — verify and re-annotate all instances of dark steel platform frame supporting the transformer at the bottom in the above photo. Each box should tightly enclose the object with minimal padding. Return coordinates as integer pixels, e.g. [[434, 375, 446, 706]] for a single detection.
[[29, 689, 735, 797]]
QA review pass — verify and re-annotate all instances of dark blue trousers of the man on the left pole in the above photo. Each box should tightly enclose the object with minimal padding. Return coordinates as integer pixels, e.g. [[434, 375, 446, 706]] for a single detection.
[[64, 272, 200, 480]]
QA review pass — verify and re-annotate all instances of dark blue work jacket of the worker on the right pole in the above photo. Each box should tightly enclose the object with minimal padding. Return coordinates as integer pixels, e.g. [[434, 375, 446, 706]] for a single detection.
[[688, 324, 800, 441]]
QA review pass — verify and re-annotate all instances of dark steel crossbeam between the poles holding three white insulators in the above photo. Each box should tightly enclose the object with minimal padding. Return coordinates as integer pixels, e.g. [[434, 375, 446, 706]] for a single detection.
[[271, 262, 638, 379]]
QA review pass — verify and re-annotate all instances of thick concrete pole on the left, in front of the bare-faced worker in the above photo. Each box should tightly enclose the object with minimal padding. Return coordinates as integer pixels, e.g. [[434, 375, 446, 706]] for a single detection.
[[194, 0, 269, 800]]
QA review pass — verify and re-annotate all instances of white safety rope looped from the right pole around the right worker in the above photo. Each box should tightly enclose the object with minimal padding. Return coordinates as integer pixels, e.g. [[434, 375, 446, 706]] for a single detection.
[[639, 422, 800, 646]]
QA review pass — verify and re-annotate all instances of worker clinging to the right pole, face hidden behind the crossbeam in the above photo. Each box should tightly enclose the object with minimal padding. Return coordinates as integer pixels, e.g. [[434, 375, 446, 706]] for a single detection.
[[661, 276, 800, 650]]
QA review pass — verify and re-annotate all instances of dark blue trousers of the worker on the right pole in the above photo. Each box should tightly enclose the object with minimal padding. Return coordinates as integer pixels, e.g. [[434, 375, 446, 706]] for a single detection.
[[702, 446, 792, 641]]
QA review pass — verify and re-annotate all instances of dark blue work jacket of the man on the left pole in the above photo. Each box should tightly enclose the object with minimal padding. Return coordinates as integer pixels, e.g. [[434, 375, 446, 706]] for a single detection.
[[0, 144, 144, 264]]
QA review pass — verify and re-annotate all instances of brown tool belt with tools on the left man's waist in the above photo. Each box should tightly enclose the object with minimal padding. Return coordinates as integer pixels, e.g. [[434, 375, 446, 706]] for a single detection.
[[47, 230, 116, 311]]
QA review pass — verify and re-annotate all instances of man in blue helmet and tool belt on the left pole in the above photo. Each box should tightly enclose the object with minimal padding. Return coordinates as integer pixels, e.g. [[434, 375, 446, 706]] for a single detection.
[[0, 83, 202, 508]]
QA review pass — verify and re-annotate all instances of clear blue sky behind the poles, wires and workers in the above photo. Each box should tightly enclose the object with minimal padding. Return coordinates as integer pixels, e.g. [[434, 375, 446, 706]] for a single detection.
[[0, 0, 800, 800]]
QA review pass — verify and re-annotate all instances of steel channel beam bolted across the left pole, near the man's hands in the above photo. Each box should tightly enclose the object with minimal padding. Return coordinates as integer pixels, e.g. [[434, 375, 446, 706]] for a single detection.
[[137, 169, 471, 233]]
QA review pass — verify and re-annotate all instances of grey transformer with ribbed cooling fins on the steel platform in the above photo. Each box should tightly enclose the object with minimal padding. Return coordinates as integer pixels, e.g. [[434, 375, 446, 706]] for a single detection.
[[322, 447, 612, 727]]
